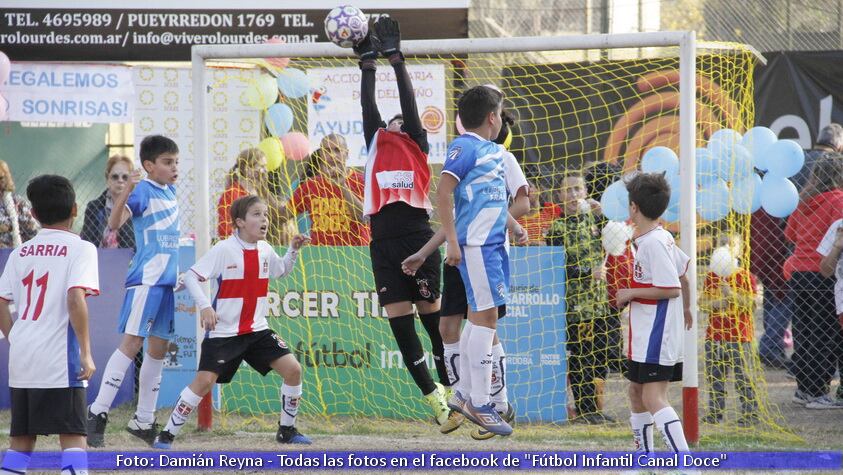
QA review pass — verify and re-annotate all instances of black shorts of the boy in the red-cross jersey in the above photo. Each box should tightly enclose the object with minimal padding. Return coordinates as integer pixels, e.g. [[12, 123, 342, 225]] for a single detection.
[[199, 330, 290, 384]]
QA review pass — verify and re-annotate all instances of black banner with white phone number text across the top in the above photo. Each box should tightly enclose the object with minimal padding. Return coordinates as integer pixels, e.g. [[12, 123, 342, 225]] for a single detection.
[[0, 0, 468, 61]]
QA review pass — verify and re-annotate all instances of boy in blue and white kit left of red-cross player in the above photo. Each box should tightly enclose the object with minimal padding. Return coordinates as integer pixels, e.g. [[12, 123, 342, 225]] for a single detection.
[[88, 135, 179, 447]]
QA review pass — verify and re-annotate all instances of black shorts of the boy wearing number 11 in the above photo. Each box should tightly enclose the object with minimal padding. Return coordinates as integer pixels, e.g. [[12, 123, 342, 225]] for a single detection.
[[9, 388, 88, 437]]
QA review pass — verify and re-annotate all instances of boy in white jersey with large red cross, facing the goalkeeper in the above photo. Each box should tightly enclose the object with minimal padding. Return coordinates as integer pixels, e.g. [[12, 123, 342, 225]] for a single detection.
[[153, 195, 310, 449]]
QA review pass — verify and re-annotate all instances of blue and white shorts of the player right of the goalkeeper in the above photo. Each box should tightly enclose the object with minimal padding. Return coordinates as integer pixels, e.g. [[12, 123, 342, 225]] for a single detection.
[[458, 243, 509, 312]]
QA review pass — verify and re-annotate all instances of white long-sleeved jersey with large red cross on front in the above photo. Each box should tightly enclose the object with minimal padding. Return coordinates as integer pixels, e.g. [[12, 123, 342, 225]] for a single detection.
[[188, 235, 297, 338]]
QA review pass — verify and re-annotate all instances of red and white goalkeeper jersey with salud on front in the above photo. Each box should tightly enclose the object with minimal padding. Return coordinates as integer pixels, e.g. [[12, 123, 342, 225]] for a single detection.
[[363, 129, 433, 216]]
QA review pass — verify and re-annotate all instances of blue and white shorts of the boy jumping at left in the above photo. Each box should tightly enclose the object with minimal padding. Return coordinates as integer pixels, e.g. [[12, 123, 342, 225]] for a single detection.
[[118, 285, 176, 340]]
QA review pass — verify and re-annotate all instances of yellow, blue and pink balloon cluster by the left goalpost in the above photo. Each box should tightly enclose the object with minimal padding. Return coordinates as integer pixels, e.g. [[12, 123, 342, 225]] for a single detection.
[[242, 39, 310, 171]]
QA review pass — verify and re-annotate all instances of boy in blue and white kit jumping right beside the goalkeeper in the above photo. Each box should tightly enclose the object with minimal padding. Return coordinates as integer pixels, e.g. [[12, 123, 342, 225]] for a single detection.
[[437, 86, 512, 435]]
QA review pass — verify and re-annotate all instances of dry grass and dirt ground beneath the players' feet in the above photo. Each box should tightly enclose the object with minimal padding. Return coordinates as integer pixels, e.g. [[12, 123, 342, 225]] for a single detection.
[[0, 364, 843, 474]]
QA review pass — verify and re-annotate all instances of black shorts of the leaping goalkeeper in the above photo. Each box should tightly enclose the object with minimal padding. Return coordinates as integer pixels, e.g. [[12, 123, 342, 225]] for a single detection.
[[369, 229, 442, 307]]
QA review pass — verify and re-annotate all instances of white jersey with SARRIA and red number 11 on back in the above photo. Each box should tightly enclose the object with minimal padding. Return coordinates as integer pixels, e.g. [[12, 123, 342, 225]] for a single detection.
[[0, 229, 99, 389]]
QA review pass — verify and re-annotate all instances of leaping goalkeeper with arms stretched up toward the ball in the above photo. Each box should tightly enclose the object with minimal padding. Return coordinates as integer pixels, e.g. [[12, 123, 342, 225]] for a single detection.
[[354, 17, 448, 424]]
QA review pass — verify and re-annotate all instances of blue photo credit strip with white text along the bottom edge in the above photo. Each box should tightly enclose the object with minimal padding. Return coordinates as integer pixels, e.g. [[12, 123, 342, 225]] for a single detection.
[[8, 451, 843, 472]]
